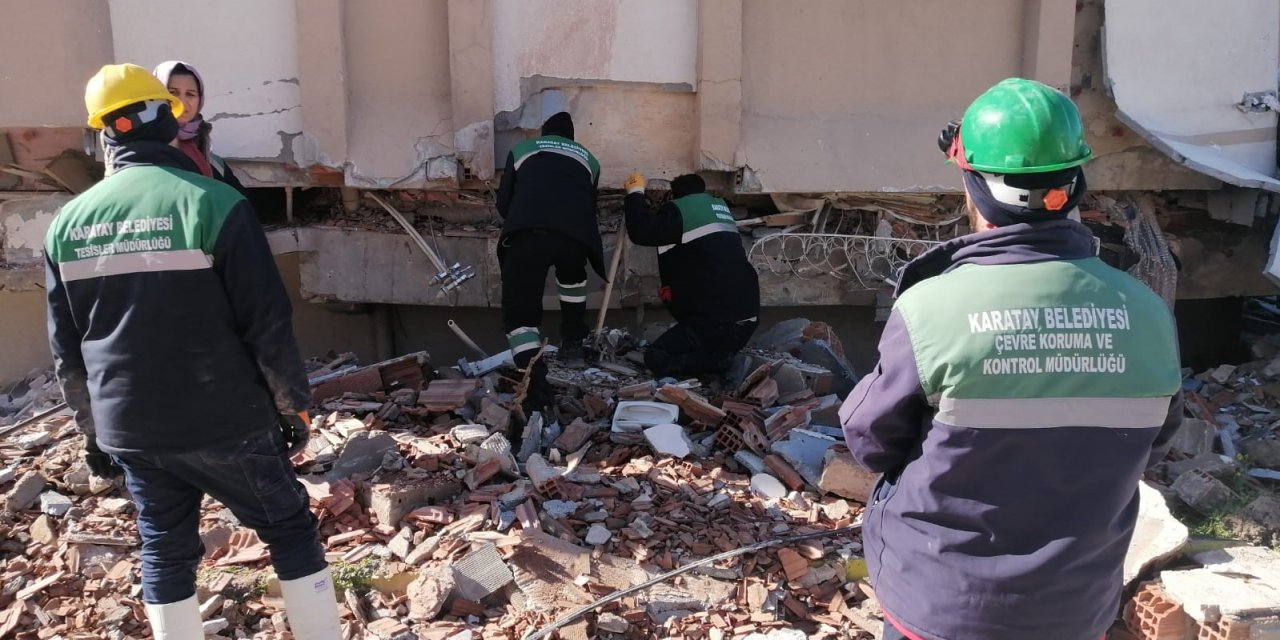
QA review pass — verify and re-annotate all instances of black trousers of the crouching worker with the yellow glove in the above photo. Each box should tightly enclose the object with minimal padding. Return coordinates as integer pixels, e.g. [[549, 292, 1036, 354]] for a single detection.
[[644, 320, 759, 378]]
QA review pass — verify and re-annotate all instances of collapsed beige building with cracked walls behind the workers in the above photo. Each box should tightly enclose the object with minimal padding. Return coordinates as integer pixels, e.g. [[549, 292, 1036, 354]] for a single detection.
[[0, 0, 1280, 380]]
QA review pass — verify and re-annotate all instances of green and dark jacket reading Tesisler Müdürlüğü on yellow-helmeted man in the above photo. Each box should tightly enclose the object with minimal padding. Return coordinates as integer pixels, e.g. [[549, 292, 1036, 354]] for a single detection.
[[45, 142, 310, 453]]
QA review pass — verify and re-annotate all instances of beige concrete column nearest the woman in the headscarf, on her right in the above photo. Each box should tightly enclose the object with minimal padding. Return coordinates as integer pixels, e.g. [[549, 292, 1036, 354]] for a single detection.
[[294, 0, 347, 166]]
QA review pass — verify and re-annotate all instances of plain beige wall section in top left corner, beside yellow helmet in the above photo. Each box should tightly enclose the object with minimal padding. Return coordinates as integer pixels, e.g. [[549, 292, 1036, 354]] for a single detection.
[[0, 0, 111, 127]]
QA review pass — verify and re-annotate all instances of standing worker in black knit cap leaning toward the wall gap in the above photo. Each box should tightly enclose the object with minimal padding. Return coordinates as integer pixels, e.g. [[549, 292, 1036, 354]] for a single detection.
[[498, 111, 604, 408]]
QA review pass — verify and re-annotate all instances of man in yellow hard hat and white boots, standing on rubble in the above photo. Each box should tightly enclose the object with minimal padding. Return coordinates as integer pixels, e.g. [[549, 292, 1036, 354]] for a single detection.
[[45, 64, 339, 640]]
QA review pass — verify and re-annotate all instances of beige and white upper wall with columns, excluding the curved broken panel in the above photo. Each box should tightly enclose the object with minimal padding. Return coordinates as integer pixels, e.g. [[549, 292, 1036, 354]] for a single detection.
[[0, 0, 1216, 192]]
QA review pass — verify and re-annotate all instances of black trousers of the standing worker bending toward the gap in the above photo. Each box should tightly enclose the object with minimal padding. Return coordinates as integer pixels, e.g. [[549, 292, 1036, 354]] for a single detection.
[[498, 230, 586, 367]]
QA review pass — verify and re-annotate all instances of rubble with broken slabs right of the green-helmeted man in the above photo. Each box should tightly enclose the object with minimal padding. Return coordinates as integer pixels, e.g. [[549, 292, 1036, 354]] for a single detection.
[[1114, 335, 1280, 640]]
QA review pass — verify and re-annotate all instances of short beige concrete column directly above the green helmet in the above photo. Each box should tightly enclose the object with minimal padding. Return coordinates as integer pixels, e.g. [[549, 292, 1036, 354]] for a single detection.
[[1021, 0, 1075, 91]]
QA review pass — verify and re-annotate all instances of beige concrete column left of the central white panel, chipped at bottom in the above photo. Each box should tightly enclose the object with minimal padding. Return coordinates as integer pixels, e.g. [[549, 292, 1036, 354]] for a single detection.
[[448, 0, 494, 180]]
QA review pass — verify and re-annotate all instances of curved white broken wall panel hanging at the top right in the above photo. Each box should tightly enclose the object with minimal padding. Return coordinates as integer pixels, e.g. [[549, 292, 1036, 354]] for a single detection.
[[1103, 0, 1280, 191]]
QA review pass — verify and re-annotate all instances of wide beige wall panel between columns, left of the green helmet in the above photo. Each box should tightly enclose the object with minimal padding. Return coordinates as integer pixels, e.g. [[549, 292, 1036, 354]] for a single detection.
[[740, 0, 1039, 192]]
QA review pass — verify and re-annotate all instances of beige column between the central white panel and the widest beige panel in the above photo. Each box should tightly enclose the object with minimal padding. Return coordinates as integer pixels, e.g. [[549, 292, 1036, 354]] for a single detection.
[[694, 0, 742, 172]]
